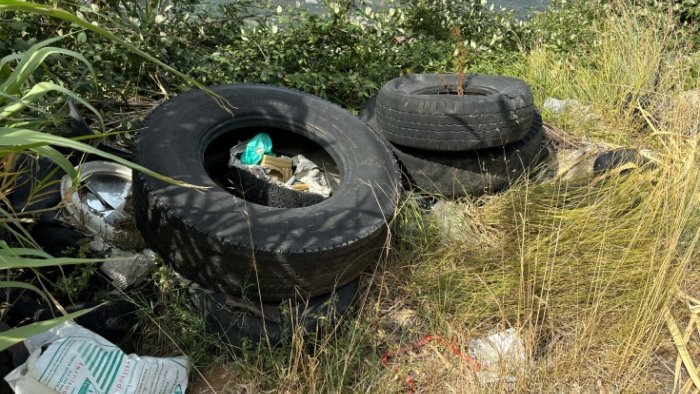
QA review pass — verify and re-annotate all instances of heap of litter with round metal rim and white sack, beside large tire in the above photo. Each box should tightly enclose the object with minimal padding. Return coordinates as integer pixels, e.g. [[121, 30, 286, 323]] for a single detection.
[[2, 156, 185, 394]]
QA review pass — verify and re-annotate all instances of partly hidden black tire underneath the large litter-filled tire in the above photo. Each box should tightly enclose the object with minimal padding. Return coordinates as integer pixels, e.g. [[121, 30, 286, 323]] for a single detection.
[[190, 279, 359, 348]]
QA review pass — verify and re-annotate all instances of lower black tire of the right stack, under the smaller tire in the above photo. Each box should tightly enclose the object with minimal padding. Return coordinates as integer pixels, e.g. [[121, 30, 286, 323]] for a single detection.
[[358, 98, 549, 198]]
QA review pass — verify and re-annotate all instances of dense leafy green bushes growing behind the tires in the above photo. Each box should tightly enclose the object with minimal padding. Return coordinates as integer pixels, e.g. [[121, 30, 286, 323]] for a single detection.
[[0, 0, 527, 108]]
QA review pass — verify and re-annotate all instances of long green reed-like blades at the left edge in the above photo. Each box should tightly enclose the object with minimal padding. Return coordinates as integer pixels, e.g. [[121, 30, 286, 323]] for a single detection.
[[0, 27, 201, 350]]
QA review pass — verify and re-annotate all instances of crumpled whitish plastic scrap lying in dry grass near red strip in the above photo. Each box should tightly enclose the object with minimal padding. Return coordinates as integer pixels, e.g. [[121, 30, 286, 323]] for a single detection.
[[469, 328, 526, 384]]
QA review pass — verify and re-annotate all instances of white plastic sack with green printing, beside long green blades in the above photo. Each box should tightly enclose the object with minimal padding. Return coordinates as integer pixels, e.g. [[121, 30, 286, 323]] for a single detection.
[[5, 321, 191, 394]]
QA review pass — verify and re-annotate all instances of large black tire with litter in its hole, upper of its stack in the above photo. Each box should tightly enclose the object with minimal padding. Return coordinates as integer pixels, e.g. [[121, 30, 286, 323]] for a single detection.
[[133, 84, 400, 301]]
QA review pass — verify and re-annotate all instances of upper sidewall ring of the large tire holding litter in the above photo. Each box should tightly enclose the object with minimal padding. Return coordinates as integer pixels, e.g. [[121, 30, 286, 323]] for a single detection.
[[136, 85, 398, 252]]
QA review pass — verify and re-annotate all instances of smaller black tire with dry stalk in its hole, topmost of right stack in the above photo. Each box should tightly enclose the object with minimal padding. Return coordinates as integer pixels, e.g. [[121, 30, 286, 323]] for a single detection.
[[377, 74, 535, 151]]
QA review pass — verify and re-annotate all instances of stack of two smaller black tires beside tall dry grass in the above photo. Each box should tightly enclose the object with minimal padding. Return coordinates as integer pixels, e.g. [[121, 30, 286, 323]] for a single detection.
[[359, 74, 547, 198]]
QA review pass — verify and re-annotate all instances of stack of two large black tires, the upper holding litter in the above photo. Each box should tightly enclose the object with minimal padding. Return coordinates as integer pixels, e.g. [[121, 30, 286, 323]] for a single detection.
[[133, 84, 400, 347]]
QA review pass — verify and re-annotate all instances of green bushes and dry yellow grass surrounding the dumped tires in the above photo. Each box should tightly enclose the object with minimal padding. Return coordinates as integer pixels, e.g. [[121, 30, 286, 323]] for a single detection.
[[0, 0, 700, 392]]
